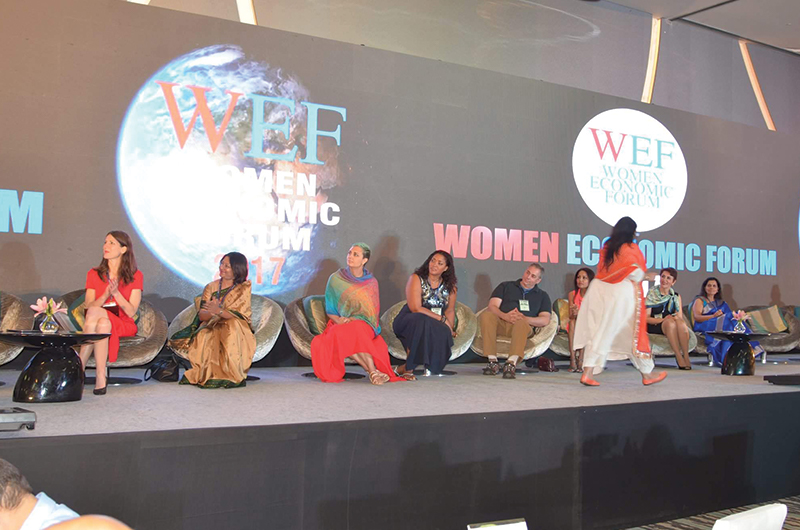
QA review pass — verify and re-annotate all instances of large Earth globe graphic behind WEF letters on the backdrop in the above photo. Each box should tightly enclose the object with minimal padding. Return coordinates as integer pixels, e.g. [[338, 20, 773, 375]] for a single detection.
[[117, 45, 338, 295]]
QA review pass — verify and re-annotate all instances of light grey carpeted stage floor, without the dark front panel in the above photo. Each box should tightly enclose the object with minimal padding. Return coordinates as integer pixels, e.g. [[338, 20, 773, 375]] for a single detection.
[[0, 354, 800, 438]]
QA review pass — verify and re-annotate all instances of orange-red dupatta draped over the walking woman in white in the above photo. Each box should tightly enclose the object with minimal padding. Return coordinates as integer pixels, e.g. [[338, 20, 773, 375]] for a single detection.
[[595, 243, 651, 359]]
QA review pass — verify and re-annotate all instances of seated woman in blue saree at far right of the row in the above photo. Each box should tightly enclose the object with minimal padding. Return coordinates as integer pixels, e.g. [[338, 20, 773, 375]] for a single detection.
[[692, 277, 764, 365]]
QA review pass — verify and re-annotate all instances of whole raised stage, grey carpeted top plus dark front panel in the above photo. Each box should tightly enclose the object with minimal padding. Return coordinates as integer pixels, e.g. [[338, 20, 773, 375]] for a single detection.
[[0, 355, 800, 529]]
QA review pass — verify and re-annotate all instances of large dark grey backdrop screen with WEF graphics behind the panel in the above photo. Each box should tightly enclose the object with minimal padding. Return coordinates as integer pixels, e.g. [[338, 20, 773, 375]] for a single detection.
[[0, 0, 800, 318]]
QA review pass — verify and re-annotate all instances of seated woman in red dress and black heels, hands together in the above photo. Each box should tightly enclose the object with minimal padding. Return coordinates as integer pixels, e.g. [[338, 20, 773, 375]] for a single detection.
[[80, 230, 144, 396]]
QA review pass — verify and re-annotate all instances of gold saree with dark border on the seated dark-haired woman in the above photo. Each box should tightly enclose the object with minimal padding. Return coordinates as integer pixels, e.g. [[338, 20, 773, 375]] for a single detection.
[[170, 281, 256, 388]]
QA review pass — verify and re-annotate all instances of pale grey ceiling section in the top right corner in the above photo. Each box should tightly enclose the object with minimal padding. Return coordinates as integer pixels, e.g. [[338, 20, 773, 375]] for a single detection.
[[611, 0, 800, 53]]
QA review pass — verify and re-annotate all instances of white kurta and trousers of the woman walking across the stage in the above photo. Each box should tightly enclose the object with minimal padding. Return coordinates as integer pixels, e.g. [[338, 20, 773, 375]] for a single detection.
[[573, 268, 654, 374]]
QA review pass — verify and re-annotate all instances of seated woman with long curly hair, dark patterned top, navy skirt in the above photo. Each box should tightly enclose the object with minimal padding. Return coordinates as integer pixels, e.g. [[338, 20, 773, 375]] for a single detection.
[[393, 250, 458, 379]]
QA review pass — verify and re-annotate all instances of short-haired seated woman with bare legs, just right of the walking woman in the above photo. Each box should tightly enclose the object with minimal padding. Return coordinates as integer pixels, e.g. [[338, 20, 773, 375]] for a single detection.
[[645, 267, 692, 370]]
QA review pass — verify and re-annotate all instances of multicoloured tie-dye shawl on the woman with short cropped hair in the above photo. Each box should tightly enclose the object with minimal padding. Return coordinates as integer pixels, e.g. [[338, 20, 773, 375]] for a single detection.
[[325, 267, 381, 335]]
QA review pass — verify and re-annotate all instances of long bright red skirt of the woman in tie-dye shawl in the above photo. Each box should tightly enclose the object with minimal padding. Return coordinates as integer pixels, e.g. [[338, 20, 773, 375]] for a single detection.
[[311, 320, 404, 383]]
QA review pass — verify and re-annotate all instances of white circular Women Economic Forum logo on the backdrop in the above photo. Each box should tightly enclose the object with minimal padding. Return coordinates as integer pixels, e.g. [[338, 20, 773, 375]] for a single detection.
[[572, 109, 686, 232]]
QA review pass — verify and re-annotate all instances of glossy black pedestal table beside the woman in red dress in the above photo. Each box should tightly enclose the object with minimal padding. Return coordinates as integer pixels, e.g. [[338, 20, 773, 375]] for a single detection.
[[0, 331, 109, 403]]
